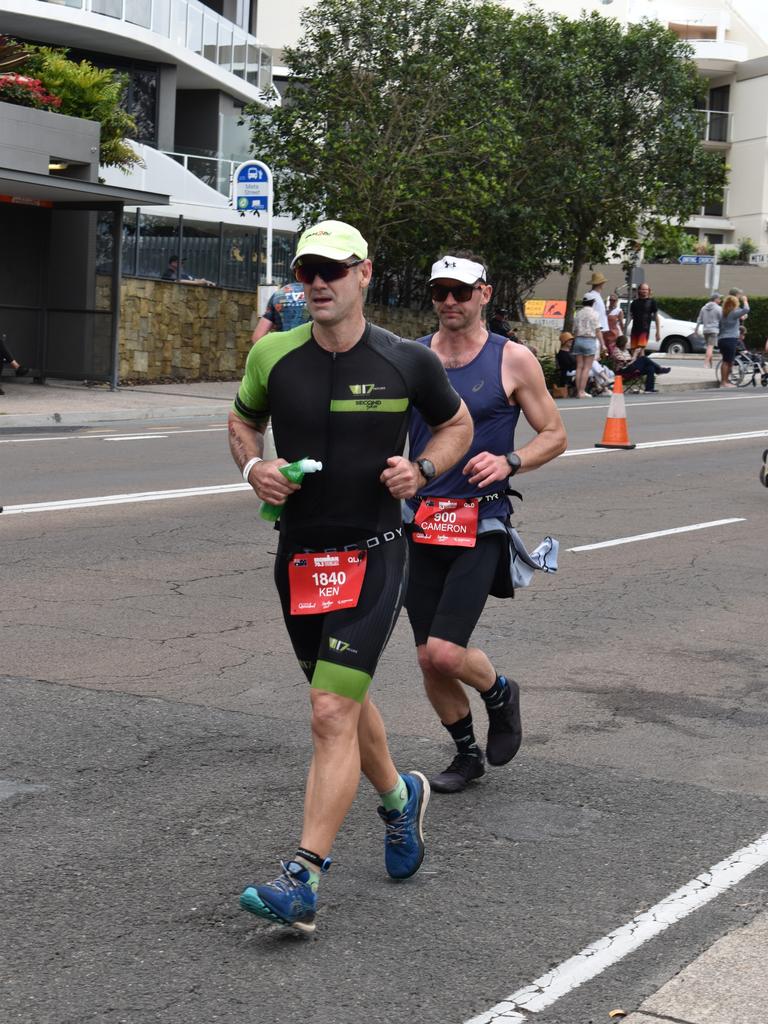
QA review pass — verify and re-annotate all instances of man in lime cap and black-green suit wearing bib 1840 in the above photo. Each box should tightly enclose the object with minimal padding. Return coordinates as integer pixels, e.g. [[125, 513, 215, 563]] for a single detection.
[[229, 220, 472, 932]]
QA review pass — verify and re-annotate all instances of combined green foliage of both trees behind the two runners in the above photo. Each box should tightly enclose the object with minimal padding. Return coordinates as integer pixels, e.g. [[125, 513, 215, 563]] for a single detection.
[[247, 0, 725, 305]]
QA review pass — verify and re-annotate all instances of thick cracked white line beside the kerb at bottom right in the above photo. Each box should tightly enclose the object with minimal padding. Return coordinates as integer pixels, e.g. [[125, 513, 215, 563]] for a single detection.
[[466, 833, 768, 1024]]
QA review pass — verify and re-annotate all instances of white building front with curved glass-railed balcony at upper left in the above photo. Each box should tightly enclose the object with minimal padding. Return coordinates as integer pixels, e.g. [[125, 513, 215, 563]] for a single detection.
[[0, 0, 276, 221]]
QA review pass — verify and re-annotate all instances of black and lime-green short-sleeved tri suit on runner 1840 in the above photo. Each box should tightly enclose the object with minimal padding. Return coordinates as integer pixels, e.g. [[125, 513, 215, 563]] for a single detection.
[[233, 324, 461, 701]]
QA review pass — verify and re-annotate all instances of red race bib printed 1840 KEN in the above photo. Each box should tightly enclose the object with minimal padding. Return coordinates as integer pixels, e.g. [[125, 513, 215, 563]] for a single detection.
[[288, 551, 367, 615]]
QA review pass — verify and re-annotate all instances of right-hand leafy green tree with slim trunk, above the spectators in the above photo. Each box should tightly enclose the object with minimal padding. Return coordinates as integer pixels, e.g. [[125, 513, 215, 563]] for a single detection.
[[512, 14, 725, 323]]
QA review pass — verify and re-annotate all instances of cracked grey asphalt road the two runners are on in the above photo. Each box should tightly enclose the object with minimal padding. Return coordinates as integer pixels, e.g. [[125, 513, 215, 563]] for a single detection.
[[0, 392, 768, 1024]]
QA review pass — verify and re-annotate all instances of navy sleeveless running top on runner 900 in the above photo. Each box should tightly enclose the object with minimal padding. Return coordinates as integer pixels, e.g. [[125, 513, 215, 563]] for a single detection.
[[408, 334, 520, 519]]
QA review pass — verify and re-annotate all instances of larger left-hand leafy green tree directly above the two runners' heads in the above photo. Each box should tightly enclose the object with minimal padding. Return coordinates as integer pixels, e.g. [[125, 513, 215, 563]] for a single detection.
[[247, 0, 519, 296]]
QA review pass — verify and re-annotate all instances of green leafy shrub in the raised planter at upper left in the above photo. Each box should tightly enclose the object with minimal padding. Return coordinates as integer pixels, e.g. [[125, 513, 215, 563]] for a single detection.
[[24, 44, 141, 170]]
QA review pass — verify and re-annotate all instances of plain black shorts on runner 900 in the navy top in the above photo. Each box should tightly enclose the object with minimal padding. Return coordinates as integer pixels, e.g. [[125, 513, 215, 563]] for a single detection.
[[406, 532, 509, 647]]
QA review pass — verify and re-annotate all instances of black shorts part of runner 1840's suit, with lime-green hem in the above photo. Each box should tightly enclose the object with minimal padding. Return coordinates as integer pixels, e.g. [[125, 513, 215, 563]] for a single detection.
[[274, 536, 408, 701]]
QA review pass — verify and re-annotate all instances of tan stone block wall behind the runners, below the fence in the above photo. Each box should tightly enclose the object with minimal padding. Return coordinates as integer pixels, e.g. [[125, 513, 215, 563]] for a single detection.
[[112, 278, 558, 383]]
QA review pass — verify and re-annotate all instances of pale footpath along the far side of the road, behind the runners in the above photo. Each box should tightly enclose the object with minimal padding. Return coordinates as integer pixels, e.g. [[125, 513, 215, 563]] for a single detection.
[[0, 356, 715, 429]]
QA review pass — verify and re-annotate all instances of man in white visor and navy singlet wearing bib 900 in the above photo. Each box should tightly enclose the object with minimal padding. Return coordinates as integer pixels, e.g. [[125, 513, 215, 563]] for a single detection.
[[406, 251, 566, 793]]
